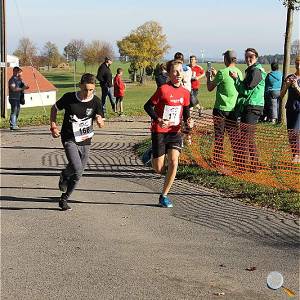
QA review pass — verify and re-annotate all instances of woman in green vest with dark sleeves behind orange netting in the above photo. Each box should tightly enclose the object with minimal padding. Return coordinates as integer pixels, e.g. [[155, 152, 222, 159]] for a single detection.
[[230, 48, 267, 172]]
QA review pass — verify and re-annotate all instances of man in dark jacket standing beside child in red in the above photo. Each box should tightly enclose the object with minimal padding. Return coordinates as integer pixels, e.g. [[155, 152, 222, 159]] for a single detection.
[[97, 56, 116, 114]]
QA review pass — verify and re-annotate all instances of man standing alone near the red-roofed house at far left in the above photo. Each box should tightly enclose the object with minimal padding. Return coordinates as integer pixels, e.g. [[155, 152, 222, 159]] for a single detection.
[[8, 67, 29, 130]]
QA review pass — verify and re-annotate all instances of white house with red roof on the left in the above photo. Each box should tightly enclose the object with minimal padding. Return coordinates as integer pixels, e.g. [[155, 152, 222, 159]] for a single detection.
[[7, 67, 57, 107]]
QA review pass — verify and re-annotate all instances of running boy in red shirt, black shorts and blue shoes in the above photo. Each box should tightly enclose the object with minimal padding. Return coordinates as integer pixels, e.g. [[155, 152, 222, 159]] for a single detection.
[[144, 60, 191, 207]]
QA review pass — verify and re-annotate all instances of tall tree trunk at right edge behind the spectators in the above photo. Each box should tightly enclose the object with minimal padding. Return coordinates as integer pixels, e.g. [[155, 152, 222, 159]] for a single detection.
[[279, 0, 300, 124]]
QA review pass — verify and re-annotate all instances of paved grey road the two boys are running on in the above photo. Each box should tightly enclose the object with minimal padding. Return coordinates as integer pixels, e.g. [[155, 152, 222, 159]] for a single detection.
[[1, 120, 300, 300]]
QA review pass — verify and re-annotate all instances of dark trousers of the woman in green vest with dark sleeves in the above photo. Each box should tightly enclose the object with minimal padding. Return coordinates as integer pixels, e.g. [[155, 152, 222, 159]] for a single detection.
[[239, 105, 263, 171]]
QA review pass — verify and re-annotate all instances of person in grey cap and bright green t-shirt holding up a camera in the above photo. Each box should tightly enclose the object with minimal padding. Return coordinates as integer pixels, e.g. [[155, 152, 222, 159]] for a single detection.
[[206, 50, 243, 168]]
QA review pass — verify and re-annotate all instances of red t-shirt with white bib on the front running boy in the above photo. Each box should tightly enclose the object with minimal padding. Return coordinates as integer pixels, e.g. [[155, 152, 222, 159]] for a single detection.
[[150, 83, 190, 133]]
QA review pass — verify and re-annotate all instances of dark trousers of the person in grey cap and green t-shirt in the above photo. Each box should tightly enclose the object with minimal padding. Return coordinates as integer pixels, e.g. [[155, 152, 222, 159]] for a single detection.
[[213, 108, 239, 165]]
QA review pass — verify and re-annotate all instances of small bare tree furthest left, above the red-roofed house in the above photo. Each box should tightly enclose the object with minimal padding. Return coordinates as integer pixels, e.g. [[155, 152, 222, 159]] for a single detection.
[[13, 38, 37, 66]]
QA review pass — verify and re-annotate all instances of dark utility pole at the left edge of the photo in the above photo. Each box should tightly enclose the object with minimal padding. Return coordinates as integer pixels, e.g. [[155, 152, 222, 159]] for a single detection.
[[0, 0, 7, 118]]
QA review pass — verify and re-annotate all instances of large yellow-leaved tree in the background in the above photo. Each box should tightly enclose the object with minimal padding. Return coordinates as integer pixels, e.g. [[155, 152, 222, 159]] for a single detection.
[[117, 21, 170, 82]]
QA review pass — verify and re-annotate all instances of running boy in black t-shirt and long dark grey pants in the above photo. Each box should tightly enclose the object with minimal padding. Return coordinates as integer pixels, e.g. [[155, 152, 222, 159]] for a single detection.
[[50, 73, 104, 210]]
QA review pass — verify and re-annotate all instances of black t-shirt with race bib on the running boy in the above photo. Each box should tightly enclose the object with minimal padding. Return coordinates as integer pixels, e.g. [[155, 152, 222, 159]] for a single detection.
[[55, 92, 103, 145]]
